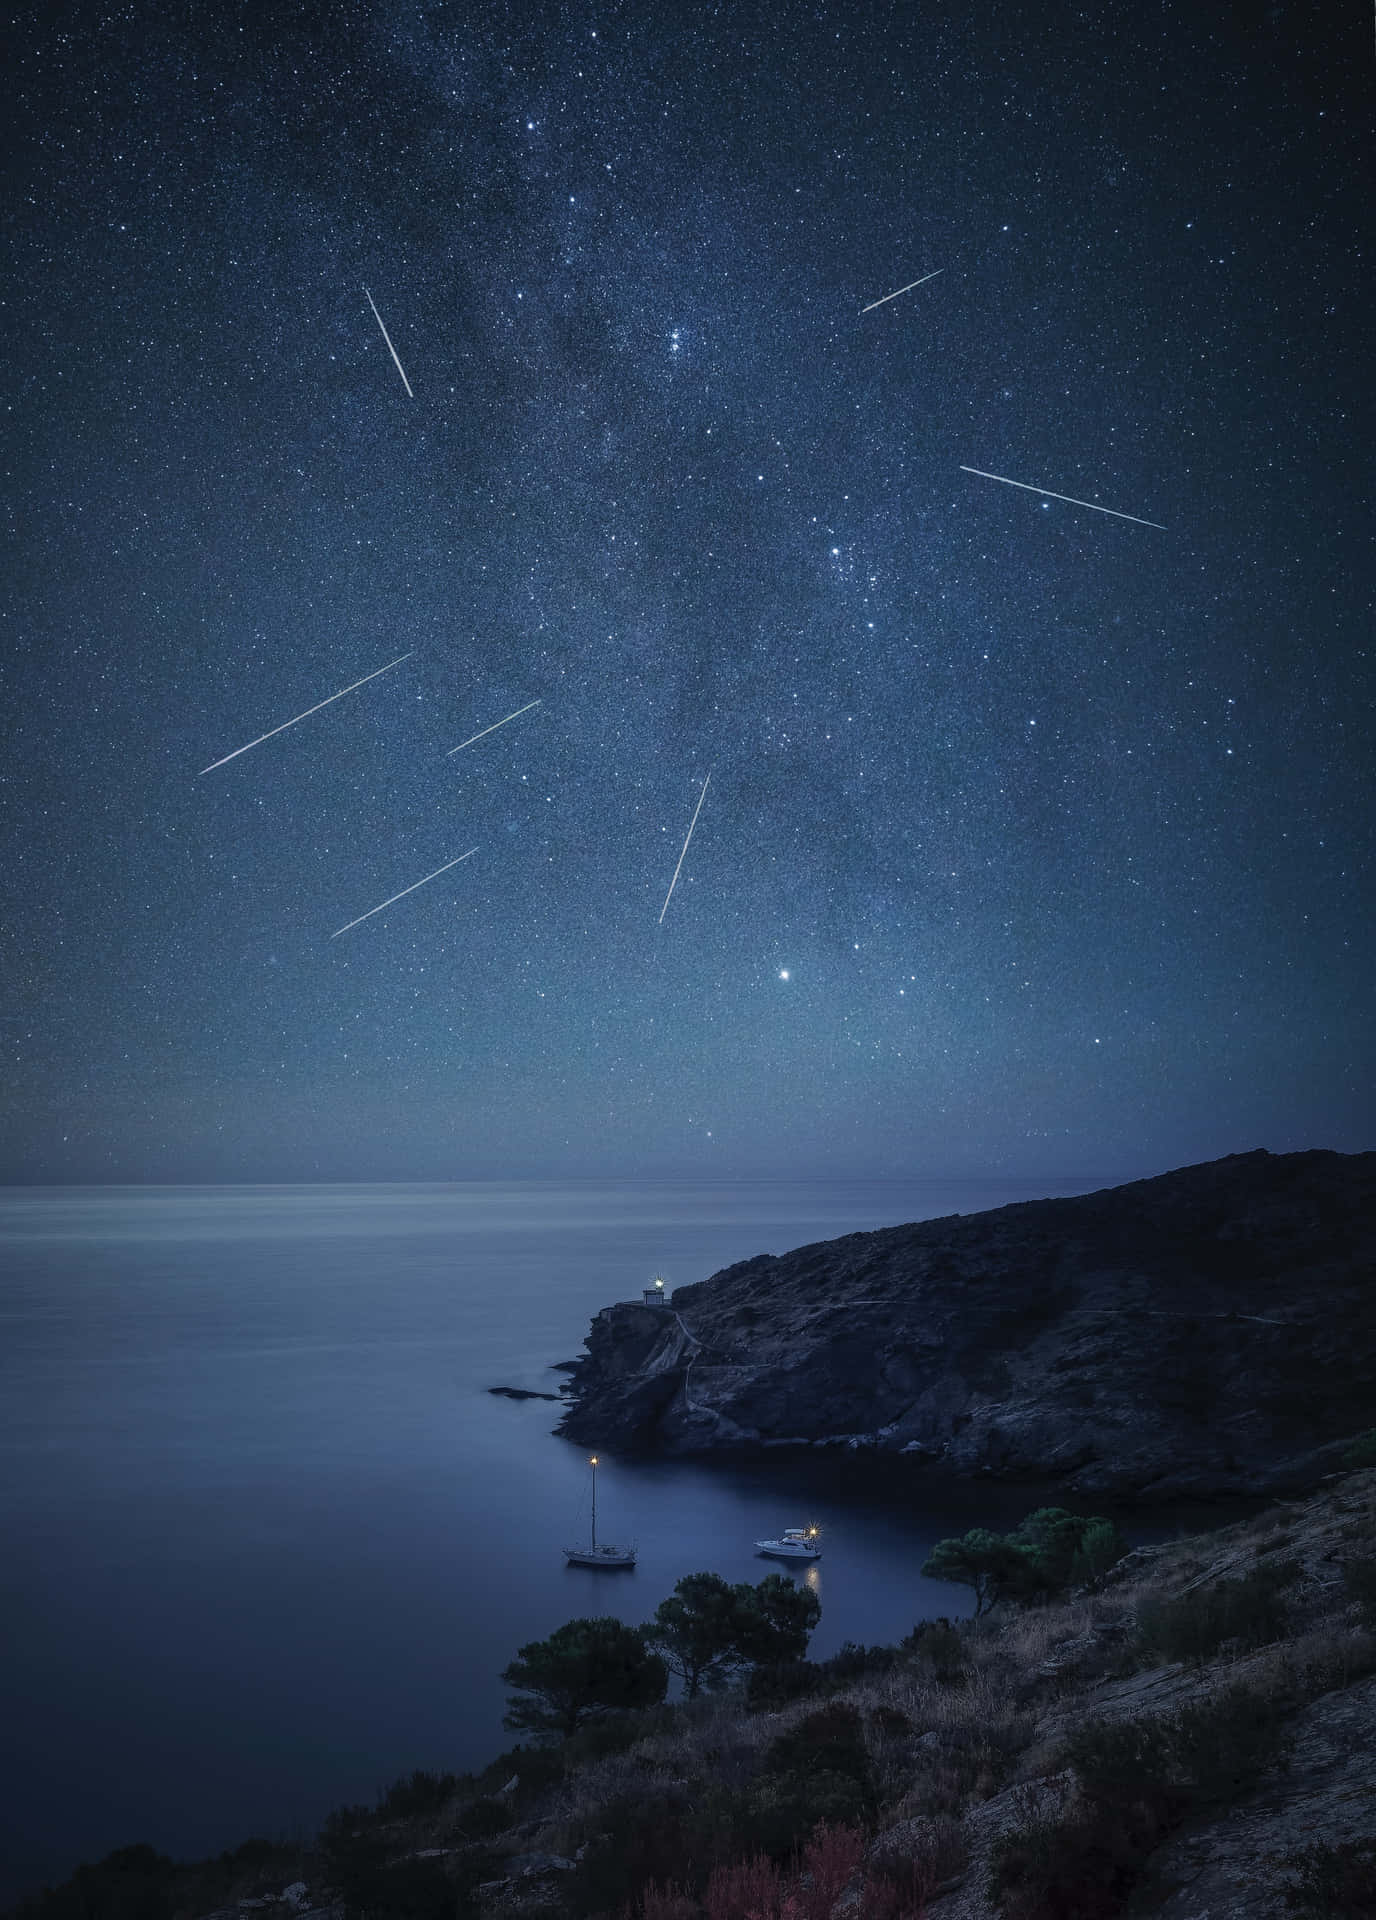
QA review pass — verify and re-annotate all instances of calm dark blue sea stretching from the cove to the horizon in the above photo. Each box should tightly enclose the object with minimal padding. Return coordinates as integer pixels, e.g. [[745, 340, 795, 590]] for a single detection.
[[0, 1181, 1102, 1905]]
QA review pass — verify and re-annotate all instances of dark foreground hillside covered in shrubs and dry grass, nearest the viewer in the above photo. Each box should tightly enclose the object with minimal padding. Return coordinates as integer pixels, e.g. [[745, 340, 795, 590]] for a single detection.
[[10, 1471, 1376, 1920]]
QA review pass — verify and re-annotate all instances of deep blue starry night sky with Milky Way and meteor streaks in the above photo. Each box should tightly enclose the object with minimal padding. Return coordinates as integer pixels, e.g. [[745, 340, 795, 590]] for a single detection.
[[0, 0, 1376, 1181]]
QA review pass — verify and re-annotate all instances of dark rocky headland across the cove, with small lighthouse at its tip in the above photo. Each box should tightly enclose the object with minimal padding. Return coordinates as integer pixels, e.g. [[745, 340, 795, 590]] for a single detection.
[[558, 1152, 1376, 1500]]
